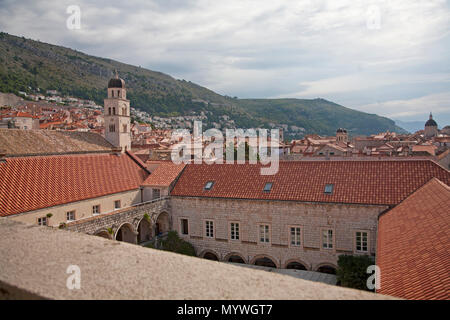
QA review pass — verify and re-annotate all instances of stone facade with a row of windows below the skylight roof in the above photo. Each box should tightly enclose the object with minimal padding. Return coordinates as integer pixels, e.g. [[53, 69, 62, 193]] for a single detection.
[[171, 196, 387, 271]]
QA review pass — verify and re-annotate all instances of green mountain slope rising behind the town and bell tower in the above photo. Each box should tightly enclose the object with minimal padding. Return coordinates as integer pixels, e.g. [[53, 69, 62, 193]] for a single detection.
[[0, 33, 402, 137]]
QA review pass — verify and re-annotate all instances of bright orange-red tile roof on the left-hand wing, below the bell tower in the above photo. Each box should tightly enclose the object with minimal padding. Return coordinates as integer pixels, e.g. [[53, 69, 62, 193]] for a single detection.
[[0, 154, 148, 216]]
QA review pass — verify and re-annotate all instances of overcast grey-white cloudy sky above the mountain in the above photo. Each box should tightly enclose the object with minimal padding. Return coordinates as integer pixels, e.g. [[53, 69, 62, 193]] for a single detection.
[[0, 0, 450, 127]]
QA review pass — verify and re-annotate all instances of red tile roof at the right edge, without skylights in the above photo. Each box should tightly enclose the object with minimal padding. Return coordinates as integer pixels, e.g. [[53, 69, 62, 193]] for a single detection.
[[377, 179, 450, 300]]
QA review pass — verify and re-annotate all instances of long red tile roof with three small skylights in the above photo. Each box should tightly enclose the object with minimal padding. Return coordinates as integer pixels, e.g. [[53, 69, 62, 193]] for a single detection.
[[171, 160, 450, 205]]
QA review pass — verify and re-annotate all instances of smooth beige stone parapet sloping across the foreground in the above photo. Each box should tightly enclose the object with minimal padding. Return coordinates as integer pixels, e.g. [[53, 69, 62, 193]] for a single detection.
[[0, 217, 391, 305]]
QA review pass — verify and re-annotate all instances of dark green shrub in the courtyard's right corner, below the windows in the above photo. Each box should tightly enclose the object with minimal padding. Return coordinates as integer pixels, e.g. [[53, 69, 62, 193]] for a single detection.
[[336, 255, 375, 291]]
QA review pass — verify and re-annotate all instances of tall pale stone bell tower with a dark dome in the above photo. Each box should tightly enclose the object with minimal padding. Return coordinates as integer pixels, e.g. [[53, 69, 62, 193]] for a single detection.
[[103, 71, 131, 152]]
